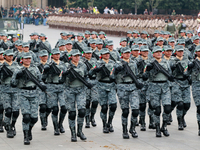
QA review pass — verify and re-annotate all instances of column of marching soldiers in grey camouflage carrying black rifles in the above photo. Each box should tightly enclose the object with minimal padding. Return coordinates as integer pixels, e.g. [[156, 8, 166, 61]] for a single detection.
[[0, 27, 200, 145]]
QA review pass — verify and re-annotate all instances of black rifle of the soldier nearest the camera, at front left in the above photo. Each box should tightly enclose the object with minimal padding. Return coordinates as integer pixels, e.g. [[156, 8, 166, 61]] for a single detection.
[[23, 68, 50, 96]]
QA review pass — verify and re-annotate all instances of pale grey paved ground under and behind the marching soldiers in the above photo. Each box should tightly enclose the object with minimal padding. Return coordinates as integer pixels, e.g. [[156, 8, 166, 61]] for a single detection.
[[0, 25, 200, 150]]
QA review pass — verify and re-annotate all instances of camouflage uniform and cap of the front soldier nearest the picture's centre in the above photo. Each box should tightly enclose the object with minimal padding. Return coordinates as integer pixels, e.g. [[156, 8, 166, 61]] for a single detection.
[[89, 48, 117, 133]]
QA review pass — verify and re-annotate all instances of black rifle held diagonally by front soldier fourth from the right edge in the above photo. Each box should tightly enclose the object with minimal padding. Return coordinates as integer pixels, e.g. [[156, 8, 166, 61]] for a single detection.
[[122, 62, 144, 89]]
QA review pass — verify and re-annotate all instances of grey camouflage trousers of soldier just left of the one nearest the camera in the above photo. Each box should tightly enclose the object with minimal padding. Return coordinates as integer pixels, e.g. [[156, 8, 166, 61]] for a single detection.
[[1, 85, 20, 124]]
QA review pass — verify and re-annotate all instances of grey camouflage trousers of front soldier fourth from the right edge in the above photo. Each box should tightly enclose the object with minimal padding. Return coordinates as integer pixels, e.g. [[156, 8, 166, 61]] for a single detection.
[[117, 84, 139, 125]]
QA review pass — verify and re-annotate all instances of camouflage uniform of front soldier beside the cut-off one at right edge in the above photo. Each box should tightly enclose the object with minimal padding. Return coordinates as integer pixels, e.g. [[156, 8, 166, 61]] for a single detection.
[[170, 45, 191, 130]]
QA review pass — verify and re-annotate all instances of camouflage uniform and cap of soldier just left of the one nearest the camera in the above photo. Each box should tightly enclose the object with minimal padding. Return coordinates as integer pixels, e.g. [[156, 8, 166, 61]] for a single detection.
[[1, 50, 19, 138]]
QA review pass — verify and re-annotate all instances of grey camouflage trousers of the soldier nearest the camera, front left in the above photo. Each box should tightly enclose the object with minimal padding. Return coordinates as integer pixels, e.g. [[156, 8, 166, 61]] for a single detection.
[[19, 89, 39, 130]]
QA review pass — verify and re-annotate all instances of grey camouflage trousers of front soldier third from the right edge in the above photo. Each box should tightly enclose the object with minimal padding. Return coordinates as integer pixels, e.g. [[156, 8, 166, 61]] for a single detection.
[[147, 82, 171, 123]]
